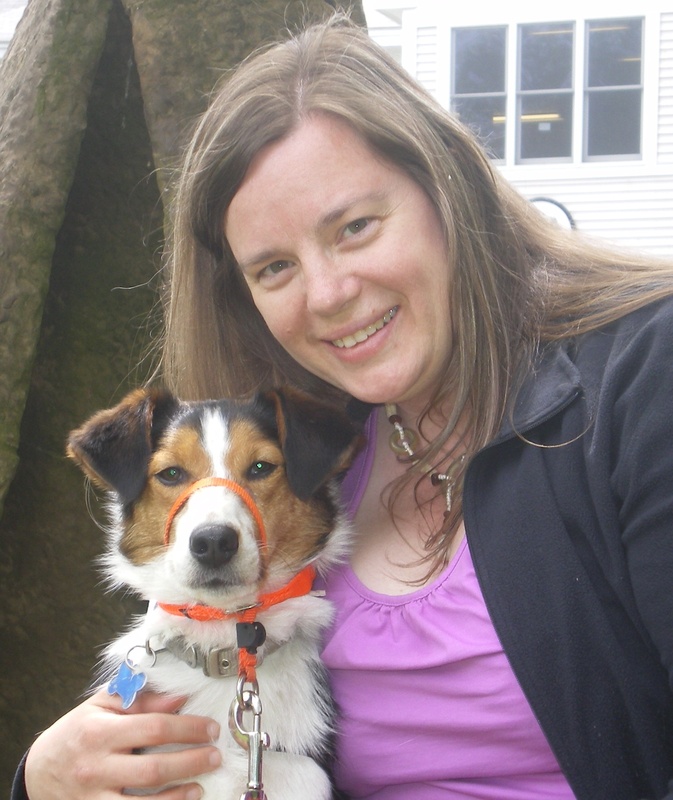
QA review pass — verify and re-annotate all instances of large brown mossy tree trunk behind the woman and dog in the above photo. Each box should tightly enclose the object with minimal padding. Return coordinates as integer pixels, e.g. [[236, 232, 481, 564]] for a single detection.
[[0, 0, 364, 793]]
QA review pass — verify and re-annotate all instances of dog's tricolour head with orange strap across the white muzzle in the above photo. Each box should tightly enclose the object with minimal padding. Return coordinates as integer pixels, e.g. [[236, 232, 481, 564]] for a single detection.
[[67, 389, 360, 605]]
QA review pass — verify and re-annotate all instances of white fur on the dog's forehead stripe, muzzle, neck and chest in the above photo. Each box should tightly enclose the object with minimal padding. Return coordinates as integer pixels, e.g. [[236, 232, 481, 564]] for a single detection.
[[98, 406, 350, 800]]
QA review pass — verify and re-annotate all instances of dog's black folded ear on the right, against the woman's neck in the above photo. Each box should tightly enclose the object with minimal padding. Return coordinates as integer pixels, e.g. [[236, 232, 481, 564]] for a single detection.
[[266, 388, 362, 500]]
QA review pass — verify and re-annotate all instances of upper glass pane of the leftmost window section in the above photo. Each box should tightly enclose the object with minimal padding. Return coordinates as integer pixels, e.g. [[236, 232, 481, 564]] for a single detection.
[[453, 28, 505, 94]]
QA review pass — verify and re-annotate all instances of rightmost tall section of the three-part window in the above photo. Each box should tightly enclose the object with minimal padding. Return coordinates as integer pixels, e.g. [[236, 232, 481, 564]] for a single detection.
[[584, 19, 643, 160]]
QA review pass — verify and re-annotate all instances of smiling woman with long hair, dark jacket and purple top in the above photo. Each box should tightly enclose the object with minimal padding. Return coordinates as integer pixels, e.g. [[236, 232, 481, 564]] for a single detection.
[[17, 16, 673, 800]]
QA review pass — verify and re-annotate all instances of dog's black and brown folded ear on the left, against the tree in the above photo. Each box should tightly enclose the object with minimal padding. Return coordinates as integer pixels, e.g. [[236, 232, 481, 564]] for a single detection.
[[66, 389, 178, 505]]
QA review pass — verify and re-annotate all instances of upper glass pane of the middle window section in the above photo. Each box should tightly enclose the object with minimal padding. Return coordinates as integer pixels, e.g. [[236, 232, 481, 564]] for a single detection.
[[520, 22, 573, 91]]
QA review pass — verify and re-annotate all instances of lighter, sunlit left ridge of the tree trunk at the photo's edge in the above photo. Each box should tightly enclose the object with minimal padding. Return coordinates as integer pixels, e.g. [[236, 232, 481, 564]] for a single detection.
[[0, 0, 110, 520]]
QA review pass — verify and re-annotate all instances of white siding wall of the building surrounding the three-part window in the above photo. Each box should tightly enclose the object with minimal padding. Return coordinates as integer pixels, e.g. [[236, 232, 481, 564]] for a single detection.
[[365, 0, 673, 256]]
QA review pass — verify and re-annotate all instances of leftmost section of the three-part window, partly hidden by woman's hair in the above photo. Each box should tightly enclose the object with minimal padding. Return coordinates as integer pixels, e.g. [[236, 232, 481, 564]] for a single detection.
[[452, 27, 507, 159]]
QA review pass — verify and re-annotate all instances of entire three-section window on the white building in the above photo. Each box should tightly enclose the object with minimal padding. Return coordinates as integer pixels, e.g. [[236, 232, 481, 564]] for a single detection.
[[451, 18, 643, 163]]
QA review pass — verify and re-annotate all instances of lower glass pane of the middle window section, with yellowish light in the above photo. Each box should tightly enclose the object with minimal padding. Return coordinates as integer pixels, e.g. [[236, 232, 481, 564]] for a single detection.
[[519, 93, 572, 159]]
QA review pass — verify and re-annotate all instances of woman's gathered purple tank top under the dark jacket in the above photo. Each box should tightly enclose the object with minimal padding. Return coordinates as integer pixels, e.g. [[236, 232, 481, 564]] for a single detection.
[[323, 414, 574, 800]]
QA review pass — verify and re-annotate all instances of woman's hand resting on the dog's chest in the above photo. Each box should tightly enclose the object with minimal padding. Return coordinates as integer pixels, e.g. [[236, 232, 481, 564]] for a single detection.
[[26, 690, 221, 800]]
